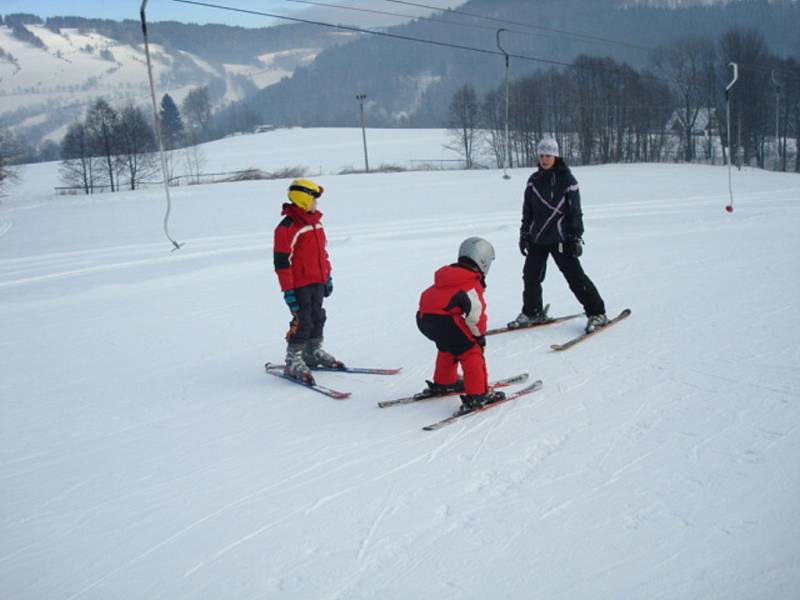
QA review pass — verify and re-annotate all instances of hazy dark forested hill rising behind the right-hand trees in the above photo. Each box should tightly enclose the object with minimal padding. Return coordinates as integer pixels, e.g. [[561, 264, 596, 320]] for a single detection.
[[231, 0, 800, 126]]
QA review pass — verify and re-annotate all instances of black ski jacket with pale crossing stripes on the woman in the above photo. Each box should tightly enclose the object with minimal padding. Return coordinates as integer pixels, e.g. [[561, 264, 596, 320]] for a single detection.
[[520, 158, 583, 245]]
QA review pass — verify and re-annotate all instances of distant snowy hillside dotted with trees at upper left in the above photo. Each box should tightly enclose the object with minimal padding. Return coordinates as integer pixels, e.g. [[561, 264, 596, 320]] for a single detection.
[[0, 25, 319, 141]]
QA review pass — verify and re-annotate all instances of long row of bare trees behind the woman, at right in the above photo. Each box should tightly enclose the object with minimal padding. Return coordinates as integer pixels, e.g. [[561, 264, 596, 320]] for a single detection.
[[448, 29, 800, 172]]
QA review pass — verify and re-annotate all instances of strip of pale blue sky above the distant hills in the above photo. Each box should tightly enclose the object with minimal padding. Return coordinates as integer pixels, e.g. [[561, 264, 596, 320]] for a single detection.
[[0, 0, 466, 27]]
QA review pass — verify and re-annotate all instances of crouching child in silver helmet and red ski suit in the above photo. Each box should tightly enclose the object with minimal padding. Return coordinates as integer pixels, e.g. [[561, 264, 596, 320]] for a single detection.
[[417, 237, 505, 412]]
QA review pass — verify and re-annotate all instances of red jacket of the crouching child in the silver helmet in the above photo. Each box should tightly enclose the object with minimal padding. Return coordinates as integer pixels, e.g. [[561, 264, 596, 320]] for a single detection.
[[419, 264, 487, 341]]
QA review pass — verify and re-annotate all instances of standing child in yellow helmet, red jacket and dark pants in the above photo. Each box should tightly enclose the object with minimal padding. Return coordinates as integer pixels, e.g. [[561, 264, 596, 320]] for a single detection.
[[273, 179, 344, 383]]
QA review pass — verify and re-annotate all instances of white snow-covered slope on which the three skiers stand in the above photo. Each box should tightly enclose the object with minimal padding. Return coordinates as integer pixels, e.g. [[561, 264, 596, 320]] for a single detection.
[[0, 130, 800, 600]]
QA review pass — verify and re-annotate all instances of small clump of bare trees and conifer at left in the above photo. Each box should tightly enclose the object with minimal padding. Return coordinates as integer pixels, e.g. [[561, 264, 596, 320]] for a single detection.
[[60, 88, 211, 194]]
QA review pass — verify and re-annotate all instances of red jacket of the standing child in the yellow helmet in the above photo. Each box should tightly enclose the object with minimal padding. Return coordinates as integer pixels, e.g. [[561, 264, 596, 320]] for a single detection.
[[273, 203, 331, 292]]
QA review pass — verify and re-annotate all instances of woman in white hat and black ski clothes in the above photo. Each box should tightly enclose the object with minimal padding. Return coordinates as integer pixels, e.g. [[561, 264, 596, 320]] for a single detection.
[[508, 138, 608, 332]]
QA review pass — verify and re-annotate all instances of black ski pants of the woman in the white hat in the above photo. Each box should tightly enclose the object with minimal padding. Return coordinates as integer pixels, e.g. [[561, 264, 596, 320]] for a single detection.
[[522, 244, 606, 317]]
